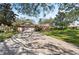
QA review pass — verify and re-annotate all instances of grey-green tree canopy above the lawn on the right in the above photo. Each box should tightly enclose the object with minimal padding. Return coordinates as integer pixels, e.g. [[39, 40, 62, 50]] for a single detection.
[[53, 3, 79, 28]]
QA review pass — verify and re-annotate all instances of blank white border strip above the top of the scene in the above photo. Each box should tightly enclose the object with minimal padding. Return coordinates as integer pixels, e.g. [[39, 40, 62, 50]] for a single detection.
[[0, 0, 79, 3]]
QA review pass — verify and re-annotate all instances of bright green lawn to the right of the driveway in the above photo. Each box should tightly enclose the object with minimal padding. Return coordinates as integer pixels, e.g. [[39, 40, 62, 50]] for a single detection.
[[42, 29, 79, 46]]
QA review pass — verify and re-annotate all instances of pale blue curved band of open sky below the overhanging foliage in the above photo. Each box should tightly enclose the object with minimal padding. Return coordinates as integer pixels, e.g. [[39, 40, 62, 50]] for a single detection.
[[13, 5, 58, 23]]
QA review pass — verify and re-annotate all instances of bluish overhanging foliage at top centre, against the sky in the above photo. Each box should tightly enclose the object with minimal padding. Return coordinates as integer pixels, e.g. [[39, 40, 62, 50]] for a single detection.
[[13, 3, 54, 17]]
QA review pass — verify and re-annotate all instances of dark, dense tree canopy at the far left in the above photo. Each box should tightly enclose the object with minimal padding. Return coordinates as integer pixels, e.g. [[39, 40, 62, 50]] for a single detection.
[[0, 3, 16, 26]]
